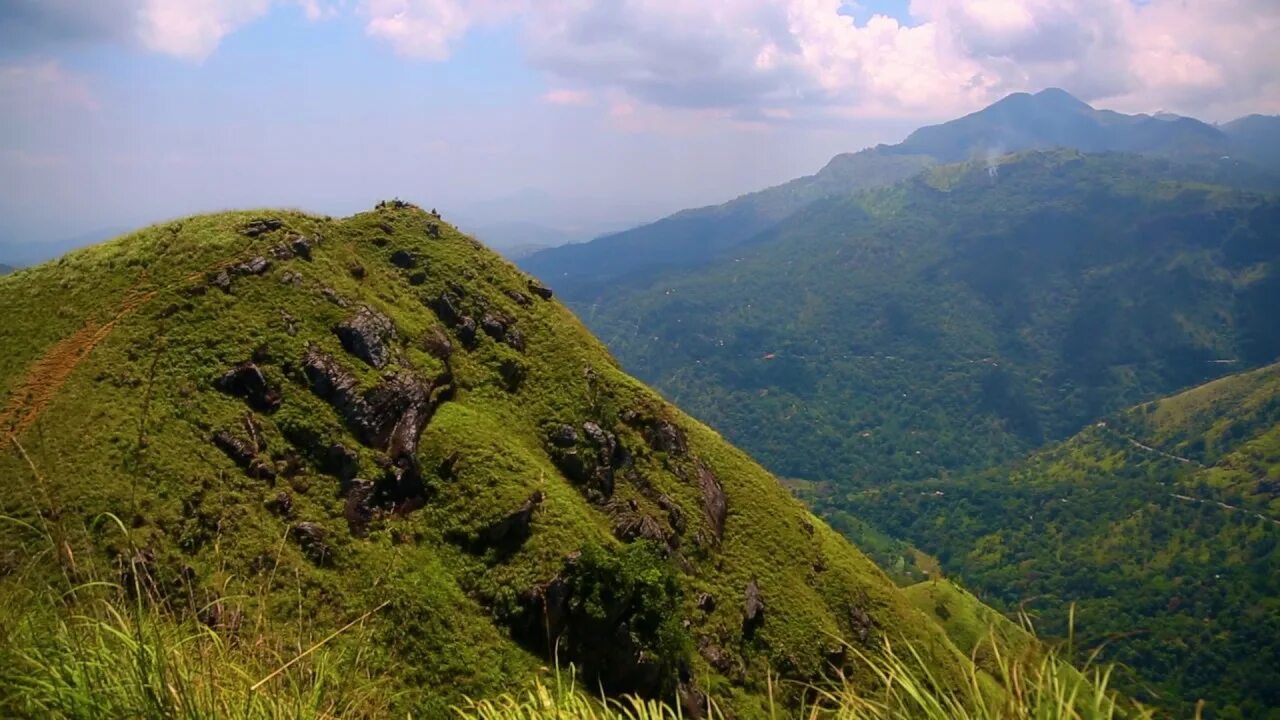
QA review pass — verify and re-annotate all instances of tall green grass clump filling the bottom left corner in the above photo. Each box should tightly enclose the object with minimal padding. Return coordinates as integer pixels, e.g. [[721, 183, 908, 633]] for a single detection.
[[0, 509, 389, 720]]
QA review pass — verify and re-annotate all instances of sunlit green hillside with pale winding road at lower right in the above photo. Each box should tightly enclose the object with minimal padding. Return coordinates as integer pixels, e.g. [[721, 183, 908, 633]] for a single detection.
[[841, 365, 1280, 717]]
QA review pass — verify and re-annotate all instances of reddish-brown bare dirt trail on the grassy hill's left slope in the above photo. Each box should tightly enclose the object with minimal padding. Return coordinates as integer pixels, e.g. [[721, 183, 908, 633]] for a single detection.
[[0, 285, 155, 446]]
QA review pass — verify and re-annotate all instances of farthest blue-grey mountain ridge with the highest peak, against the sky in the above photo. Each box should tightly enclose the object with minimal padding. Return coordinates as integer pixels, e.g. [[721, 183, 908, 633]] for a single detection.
[[521, 88, 1280, 297]]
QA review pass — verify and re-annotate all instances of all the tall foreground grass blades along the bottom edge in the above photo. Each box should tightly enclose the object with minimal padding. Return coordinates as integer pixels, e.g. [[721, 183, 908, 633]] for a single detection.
[[0, 509, 1152, 720]]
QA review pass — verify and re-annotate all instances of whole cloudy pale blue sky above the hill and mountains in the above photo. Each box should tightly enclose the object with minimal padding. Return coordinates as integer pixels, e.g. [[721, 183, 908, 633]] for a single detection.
[[0, 0, 1280, 252]]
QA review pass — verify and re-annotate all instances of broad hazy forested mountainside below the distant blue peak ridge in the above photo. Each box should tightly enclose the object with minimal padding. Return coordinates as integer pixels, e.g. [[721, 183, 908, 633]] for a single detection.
[[582, 151, 1280, 486]]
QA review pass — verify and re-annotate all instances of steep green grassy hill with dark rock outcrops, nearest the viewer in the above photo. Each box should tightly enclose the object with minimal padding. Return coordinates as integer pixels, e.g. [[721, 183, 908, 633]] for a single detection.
[[0, 201, 988, 717]]
